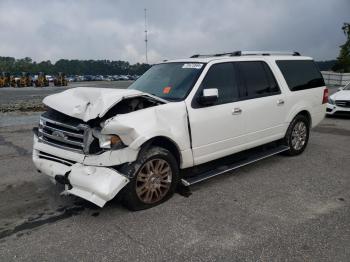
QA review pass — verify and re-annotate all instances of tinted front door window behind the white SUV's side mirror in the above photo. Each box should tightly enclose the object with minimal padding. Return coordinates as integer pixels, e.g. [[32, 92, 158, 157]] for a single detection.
[[201, 63, 238, 104]]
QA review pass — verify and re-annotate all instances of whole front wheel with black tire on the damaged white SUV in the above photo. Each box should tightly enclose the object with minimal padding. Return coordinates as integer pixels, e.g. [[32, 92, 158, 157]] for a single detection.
[[120, 147, 179, 211]]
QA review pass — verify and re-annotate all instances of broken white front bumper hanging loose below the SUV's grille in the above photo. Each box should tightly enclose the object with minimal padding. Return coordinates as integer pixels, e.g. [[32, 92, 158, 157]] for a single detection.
[[33, 136, 129, 207]]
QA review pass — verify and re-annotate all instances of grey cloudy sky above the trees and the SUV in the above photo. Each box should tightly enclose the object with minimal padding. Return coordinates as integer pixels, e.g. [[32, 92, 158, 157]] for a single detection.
[[0, 0, 350, 63]]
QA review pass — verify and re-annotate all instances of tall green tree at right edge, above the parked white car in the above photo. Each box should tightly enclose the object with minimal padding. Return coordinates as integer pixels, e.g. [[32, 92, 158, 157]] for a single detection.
[[333, 23, 350, 73]]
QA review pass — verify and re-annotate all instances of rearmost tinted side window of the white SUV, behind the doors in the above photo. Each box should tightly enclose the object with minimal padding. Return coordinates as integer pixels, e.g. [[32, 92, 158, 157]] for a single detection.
[[276, 60, 325, 91]]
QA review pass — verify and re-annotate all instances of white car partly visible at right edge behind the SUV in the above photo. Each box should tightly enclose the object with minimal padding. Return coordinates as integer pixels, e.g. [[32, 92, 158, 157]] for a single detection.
[[327, 82, 350, 115]]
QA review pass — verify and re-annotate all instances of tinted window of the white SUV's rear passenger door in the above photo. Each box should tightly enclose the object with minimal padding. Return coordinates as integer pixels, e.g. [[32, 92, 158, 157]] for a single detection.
[[237, 61, 280, 98]]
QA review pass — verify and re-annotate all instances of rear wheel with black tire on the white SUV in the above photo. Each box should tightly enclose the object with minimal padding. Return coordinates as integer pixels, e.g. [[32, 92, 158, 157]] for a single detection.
[[284, 115, 310, 156]]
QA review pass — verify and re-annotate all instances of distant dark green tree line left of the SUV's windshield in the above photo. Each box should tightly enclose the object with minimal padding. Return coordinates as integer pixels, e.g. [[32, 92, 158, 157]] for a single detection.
[[0, 57, 150, 75]]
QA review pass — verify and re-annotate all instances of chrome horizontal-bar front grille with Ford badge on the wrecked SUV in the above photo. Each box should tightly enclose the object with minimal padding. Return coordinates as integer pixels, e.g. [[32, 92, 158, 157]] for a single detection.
[[38, 114, 91, 153]]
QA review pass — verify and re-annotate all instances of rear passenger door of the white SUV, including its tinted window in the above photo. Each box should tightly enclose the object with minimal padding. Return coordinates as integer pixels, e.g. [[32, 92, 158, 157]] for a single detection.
[[235, 61, 287, 147]]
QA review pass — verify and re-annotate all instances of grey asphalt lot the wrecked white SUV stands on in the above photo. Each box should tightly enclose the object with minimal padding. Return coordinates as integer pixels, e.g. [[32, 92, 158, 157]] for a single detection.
[[0, 89, 350, 261]]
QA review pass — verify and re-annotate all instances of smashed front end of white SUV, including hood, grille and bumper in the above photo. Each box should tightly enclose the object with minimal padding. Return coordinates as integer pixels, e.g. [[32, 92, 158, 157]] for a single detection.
[[33, 88, 165, 207]]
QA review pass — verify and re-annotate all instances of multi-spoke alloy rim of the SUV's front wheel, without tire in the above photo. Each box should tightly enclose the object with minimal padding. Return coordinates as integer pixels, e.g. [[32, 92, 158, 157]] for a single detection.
[[136, 158, 172, 204]]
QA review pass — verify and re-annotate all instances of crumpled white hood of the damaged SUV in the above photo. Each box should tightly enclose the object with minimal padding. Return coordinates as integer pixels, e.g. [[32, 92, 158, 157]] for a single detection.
[[43, 87, 164, 122]]
